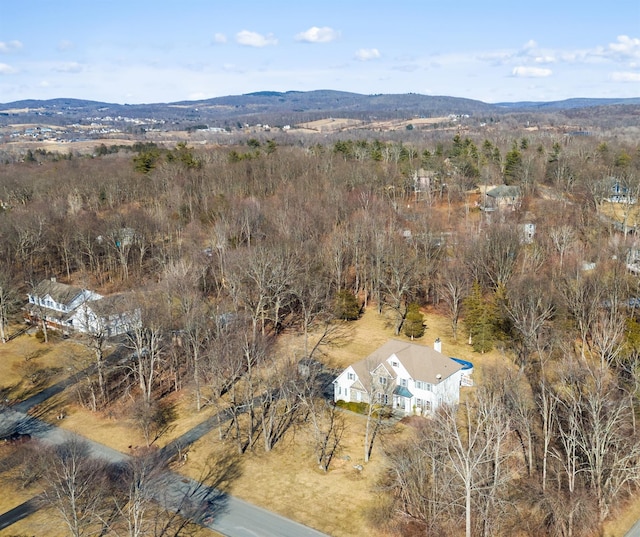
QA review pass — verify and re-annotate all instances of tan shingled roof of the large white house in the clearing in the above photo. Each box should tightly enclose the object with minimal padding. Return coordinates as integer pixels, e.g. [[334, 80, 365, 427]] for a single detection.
[[351, 339, 463, 384]]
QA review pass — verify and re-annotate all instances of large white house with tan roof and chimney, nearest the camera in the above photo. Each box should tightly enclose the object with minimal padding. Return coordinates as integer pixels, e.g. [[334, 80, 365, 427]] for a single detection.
[[333, 339, 473, 415]]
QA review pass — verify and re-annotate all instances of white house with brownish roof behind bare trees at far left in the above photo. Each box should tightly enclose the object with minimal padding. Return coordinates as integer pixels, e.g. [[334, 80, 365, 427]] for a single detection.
[[25, 278, 140, 337]]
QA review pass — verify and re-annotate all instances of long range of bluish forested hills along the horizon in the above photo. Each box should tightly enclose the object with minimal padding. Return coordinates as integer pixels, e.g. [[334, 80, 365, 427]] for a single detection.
[[0, 90, 640, 125]]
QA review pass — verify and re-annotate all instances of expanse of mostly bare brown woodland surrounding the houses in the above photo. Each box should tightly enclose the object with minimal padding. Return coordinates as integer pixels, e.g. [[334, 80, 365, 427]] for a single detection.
[[0, 122, 640, 537]]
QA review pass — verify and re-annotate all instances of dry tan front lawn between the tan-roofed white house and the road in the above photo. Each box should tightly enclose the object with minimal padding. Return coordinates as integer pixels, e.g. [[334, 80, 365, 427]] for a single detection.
[[180, 406, 396, 537]]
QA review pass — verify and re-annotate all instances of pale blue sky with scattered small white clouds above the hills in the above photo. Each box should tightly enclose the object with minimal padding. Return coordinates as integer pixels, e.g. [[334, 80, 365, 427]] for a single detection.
[[0, 0, 640, 104]]
